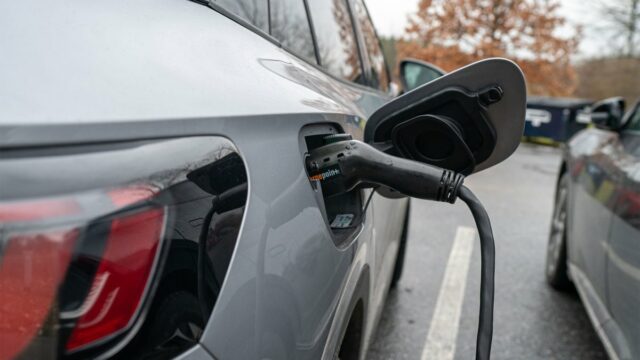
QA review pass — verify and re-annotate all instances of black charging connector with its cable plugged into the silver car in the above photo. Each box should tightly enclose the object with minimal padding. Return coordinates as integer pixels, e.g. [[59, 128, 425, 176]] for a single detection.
[[306, 134, 495, 360]]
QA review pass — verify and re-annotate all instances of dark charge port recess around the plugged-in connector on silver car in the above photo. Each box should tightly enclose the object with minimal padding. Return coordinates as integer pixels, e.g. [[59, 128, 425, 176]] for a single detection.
[[300, 124, 364, 246]]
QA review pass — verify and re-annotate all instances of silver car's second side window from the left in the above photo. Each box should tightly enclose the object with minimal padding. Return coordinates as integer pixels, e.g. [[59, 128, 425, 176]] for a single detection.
[[269, 0, 316, 63]]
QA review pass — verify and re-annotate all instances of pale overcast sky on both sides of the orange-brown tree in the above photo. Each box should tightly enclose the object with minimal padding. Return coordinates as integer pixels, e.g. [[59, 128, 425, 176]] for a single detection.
[[365, 0, 610, 57]]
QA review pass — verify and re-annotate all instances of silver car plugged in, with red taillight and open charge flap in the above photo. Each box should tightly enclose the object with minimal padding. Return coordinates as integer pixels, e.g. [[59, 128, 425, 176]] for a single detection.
[[0, 0, 525, 359]]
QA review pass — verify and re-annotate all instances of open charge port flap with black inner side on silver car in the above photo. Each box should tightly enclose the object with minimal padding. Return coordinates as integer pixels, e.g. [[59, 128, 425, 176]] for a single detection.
[[364, 58, 527, 175]]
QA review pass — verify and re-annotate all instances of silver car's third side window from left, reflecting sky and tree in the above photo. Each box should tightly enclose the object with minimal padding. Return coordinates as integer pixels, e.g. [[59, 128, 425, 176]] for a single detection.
[[308, 0, 365, 84]]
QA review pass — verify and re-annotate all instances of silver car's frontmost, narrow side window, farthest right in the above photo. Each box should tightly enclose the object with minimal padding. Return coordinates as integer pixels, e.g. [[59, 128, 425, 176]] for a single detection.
[[354, 0, 389, 91]]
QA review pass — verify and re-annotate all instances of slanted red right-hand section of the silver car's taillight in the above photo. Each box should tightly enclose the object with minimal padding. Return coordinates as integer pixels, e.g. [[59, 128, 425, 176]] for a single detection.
[[66, 209, 164, 351]]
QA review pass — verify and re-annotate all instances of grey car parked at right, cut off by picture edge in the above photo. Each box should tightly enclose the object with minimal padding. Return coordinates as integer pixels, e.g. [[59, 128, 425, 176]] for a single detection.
[[546, 98, 640, 359]]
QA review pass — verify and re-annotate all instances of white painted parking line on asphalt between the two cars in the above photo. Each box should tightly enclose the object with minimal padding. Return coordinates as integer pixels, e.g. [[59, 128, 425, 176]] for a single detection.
[[422, 226, 476, 360]]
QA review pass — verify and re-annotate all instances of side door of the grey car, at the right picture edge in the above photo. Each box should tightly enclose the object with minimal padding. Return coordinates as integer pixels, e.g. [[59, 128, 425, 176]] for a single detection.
[[603, 105, 640, 359]]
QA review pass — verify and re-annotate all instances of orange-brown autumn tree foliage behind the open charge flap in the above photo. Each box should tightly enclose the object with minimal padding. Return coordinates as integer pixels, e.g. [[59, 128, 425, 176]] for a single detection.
[[397, 0, 578, 96]]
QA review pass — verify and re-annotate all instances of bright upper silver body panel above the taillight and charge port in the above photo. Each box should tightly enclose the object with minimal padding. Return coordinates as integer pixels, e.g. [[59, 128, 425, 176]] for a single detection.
[[0, 0, 385, 146]]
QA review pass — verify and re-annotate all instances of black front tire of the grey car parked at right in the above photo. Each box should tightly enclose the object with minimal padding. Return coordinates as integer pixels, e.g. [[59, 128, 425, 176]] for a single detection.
[[545, 173, 571, 290]]
